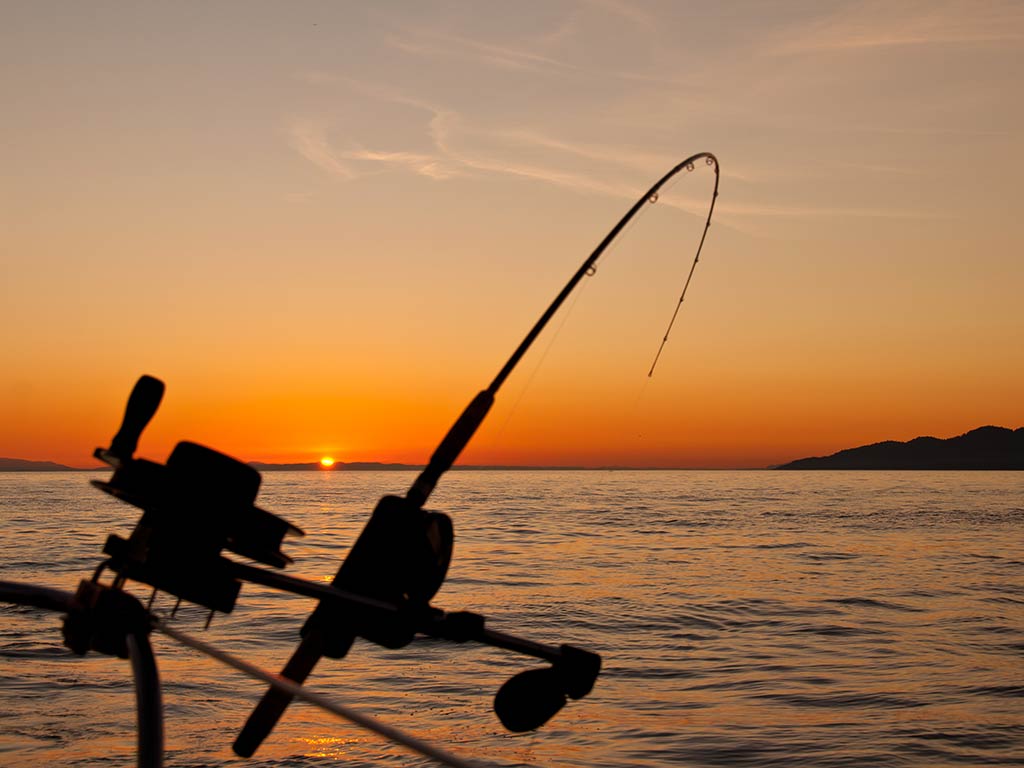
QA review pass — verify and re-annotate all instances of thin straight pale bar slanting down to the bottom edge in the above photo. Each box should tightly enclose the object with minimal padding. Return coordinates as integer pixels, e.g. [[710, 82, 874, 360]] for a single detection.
[[153, 620, 487, 768]]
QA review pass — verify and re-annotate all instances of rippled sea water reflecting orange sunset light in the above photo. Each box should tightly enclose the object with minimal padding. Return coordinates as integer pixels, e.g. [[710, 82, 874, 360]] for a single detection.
[[0, 471, 1024, 768]]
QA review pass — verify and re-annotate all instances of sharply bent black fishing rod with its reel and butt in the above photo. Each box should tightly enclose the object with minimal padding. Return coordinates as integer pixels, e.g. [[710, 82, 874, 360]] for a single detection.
[[233, 152, 720, 757]]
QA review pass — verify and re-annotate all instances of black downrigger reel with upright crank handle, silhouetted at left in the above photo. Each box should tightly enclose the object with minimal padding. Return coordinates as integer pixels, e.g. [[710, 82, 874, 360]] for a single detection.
[[92, 376, 303, 613]]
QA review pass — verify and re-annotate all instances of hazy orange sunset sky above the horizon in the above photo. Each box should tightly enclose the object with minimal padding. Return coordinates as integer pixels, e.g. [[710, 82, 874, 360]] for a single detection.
[[0, 0, 1024, 467]]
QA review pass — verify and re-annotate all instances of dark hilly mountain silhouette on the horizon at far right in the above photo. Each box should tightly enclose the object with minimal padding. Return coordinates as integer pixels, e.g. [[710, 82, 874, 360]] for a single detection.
[[777, 427, 1024, 469]]
